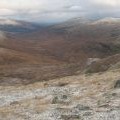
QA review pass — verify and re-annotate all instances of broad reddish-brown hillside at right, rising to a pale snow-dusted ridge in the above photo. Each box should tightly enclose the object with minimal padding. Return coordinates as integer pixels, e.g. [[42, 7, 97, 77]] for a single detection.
[[13, 19, 120, 64]]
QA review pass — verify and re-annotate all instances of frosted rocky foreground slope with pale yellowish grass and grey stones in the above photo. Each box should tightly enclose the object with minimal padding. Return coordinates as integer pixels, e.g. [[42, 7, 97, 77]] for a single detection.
[[0, 70, 120, 120]]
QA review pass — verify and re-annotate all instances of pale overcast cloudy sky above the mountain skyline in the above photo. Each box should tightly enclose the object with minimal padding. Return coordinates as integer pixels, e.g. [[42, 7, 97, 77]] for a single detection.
[[0, 0, 120, 23]]
